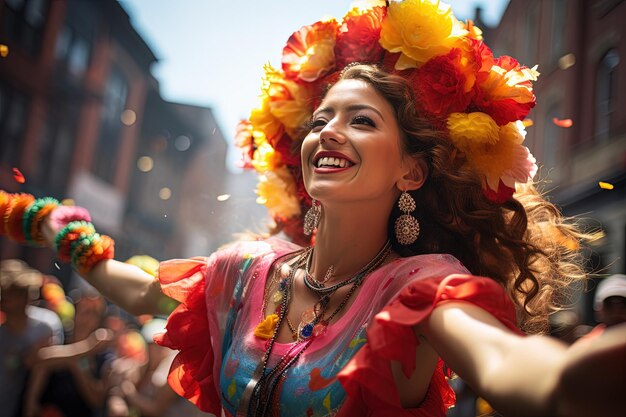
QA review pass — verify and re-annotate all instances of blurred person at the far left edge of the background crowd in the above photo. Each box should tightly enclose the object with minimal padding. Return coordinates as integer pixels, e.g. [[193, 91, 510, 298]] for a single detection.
[[0, 259, 63, 417]]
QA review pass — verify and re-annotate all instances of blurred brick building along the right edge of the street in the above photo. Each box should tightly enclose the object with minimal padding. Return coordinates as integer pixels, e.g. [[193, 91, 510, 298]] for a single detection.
[[487, 0, 626, 318]]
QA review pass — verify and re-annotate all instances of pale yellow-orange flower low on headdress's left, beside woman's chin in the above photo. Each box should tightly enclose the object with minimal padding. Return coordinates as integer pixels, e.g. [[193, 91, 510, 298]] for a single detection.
[[256, 165, 300, 219]]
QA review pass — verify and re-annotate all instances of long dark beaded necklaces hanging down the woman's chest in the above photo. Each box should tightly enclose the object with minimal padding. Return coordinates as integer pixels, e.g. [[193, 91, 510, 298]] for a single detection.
[[244, 241, 391, 417]]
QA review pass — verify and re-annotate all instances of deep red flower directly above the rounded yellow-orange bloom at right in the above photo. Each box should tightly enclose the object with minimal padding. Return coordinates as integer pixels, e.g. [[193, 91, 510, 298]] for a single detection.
[[413, 48, 472, 118]]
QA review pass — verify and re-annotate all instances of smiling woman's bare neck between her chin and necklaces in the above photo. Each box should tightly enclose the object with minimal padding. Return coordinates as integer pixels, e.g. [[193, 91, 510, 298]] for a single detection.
[[311, 202, 389, 281]]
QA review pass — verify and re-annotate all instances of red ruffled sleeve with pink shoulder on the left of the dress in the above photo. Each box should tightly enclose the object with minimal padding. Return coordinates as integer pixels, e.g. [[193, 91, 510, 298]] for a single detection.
[[155, 239, 292, 416]]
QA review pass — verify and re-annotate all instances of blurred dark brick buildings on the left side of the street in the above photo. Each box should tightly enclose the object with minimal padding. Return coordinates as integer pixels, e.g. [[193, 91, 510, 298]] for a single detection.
[[0, 0, 227, 279]]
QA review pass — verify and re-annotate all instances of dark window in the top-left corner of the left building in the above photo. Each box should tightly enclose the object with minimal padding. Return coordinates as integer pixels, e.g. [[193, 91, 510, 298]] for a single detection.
[[0, 0, 50, 55]]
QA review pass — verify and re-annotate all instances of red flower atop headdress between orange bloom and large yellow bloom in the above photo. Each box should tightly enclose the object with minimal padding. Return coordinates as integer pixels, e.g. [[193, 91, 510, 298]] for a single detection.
[[335, 7, 386, 68]]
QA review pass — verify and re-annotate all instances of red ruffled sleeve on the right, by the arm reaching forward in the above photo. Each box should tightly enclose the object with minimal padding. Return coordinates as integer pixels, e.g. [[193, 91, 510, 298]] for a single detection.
[[338, 274, 521, 417]]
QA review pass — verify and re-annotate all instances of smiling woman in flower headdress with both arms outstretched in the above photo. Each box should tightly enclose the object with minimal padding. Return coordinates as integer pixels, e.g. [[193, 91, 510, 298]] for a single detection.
[[2, 0, 626, 416]]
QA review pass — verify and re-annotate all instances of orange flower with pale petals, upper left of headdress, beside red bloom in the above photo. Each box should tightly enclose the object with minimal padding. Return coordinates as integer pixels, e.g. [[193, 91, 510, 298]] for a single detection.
[[282, 19, 338, 82]]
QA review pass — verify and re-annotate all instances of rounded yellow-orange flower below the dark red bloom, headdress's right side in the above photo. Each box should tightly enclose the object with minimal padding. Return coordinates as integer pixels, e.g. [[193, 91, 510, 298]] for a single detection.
[[447, 112, 499, 153]]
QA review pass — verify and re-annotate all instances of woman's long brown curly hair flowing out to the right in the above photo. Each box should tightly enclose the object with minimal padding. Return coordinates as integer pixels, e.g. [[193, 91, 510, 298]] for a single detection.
[[339, 64, 585, 333]]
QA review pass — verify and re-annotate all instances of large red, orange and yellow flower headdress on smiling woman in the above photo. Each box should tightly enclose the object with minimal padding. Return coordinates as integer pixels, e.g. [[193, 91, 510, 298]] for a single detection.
[[237, 0, 539, 242]]
